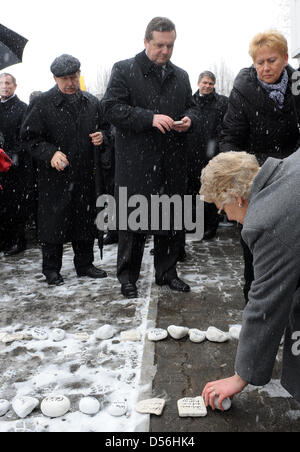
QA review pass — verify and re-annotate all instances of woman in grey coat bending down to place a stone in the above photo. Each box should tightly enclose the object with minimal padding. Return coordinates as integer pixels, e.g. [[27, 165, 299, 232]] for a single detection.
[[201, 150, 300, 409]]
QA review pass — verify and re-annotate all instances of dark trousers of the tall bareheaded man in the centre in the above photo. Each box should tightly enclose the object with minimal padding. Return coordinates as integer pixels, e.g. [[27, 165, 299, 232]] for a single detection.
[[117, 231, 184, 284]]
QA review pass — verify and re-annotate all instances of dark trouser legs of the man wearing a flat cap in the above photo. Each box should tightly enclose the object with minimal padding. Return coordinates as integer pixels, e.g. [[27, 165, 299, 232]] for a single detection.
[[42, 241, 94, 276]]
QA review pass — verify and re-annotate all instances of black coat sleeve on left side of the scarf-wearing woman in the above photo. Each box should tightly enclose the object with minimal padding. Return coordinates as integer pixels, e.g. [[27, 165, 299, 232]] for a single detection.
[[219, 89, 250, 152]]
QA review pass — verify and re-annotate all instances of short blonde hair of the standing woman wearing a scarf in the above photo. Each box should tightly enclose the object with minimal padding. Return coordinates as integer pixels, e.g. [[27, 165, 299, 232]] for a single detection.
[[249, 30, 288, 61]]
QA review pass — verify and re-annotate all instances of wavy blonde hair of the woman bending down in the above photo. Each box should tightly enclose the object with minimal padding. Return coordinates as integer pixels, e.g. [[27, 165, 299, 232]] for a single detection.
[[200, 152, 260, 209]]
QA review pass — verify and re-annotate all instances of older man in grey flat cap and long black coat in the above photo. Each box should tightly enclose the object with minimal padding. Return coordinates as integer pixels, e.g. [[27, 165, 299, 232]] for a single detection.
[[21, 55, 107, 285]]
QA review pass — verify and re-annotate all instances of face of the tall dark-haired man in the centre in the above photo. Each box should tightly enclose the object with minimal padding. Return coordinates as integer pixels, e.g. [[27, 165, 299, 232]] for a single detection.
[[144, 31, 176, 66]]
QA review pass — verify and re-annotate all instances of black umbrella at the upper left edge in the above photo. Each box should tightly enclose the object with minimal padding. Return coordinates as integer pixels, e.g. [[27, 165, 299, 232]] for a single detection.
[[0, 24, 28, 70]]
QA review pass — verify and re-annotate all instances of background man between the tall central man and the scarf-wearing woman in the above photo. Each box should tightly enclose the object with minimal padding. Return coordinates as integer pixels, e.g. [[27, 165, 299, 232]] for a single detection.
[[187, 71, 228, 240]]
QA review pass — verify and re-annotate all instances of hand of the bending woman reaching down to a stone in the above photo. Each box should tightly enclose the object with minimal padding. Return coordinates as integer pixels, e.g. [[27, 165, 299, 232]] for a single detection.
[[202, 375, 248, 411]]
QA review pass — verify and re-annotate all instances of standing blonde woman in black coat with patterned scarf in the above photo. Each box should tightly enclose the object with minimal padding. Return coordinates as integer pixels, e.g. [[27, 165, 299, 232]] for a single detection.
[[220, 31, 300, 301]]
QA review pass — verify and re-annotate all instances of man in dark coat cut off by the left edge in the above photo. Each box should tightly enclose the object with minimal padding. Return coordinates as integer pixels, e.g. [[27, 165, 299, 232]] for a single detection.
[[0, 73, 32, 256]]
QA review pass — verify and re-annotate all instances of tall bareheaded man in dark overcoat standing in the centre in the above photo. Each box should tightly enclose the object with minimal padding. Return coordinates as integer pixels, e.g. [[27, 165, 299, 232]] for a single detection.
[[103, 17, 198, 298]]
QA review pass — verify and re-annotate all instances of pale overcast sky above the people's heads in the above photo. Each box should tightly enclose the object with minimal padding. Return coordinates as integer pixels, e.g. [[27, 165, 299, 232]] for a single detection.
[[1, 0, 290, 102]]
